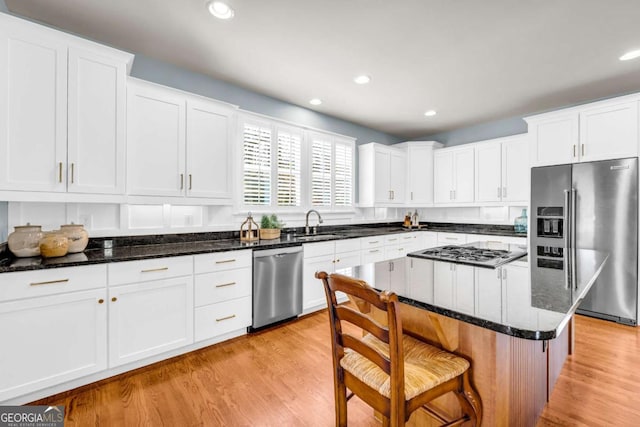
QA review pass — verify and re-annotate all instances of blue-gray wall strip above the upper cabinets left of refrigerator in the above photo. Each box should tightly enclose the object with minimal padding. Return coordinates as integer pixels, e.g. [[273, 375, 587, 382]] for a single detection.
[[415, 117, 527, 147]]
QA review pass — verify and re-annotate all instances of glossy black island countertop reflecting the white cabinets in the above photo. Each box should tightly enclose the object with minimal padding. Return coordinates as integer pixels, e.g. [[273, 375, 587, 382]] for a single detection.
[[338, 249, 608, 340]]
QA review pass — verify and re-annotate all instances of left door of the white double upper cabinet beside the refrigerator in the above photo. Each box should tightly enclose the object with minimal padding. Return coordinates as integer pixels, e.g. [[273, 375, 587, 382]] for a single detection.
[[475, 142, 502, 202]]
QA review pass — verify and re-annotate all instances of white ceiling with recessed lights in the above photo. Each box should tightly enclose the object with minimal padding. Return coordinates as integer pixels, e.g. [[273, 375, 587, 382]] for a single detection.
[[6, 0, 640, 138]]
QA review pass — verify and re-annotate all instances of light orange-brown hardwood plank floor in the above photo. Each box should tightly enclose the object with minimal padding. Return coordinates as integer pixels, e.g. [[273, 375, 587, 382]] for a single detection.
[[34, 311, 640, 427]]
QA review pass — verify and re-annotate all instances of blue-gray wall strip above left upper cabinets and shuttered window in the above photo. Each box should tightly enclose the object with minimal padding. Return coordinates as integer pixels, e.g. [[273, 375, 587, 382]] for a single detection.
[[131, 54, 402, 144]]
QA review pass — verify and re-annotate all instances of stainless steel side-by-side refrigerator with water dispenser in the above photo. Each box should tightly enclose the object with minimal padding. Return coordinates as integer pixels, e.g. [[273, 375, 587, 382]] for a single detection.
[[530, 158, 638, 325]]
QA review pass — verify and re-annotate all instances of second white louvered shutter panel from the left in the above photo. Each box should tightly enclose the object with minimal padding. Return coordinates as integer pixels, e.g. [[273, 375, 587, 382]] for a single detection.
[[276, 129, 302, 206]]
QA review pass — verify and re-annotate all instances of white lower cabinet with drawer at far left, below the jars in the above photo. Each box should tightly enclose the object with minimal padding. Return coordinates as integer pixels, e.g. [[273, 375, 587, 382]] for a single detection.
[[0, 266, 107, 402]]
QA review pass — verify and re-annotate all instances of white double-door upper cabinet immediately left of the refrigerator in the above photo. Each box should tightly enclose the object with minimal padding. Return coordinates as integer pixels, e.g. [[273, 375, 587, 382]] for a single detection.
[[475, 135, 530, 202]]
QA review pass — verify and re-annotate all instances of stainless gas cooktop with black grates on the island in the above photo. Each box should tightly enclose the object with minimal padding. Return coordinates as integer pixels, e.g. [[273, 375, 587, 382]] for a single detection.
[[407, 245, 527, 268]]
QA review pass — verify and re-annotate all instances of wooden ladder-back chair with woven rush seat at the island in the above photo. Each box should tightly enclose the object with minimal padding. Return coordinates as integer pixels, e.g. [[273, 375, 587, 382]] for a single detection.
[[316, 271, 482, 427]]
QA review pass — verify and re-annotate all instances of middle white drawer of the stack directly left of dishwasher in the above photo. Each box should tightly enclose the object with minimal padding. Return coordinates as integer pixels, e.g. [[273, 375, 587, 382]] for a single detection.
[[196, 268, 251, 307]]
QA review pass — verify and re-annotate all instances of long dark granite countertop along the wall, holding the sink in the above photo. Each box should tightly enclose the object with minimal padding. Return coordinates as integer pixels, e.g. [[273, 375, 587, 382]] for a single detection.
[[0, 223, 526, 273]]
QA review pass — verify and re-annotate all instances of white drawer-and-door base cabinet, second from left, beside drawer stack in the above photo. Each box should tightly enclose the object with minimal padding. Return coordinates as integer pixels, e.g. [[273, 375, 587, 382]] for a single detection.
[[108, 256, 194, 367]]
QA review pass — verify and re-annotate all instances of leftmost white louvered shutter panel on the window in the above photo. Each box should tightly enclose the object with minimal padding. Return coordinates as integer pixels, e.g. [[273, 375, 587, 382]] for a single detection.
[[242, 123, 271, 206]]
